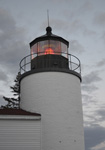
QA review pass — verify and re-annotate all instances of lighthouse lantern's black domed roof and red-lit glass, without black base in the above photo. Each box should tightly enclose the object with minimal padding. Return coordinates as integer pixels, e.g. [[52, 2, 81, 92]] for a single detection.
[[30, 27, 69, 59]]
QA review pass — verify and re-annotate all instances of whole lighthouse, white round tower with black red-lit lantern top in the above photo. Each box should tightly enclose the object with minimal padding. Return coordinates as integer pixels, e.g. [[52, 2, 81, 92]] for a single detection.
[[20, 26, 84, 150]]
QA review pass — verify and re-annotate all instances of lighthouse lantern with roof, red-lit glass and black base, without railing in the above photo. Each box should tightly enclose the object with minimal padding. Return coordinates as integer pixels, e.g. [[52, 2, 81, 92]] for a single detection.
[[30, 27, 69, 69]]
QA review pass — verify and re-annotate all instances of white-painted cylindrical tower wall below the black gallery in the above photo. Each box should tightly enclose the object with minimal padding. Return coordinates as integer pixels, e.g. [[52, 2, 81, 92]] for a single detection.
[[21, 72, 84, 150]]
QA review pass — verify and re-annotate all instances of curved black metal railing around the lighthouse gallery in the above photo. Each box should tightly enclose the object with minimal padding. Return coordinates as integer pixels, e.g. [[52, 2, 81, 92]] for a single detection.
[[19, 52, 81, 74]]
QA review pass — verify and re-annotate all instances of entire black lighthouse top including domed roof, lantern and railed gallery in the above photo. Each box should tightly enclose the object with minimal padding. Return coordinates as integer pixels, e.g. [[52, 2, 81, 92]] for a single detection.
[[20, 26, 81, 79]]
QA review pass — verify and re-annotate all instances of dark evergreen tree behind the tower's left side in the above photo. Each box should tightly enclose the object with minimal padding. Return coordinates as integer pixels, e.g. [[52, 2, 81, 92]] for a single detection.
[[1, 72, 20, 109]]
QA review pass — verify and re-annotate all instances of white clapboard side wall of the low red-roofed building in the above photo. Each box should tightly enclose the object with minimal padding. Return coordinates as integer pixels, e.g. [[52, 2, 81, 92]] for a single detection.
[[0, 115, 41, 150]]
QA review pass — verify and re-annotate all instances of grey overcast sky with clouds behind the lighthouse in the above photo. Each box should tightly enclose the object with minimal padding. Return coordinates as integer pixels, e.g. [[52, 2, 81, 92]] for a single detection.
[[0, 0, 105, 150]]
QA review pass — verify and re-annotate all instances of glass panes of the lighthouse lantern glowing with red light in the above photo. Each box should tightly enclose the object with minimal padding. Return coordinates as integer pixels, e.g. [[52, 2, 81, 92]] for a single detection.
[[31, 40, 68, 59]]
